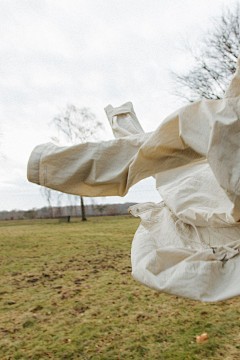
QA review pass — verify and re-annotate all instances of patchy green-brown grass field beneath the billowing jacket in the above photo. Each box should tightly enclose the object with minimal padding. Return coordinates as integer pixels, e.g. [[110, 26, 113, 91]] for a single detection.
[[0, 216, 240, 360]]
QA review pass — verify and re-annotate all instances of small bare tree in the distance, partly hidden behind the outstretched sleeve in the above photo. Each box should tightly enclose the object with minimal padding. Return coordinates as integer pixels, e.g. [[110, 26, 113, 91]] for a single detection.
[[52, 104, 103, 221]]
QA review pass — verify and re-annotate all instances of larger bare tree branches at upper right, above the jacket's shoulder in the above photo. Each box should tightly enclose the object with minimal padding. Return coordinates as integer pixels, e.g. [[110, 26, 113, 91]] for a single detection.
[[171, 3, 240, 102]]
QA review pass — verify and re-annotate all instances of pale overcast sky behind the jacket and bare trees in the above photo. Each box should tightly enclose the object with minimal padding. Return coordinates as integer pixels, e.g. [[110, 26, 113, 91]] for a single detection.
[[0, 0, 235, 211]]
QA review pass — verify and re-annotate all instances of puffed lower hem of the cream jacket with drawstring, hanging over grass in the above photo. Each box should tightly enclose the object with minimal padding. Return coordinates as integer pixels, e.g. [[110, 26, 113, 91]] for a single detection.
[[130, 202, 240, 302]]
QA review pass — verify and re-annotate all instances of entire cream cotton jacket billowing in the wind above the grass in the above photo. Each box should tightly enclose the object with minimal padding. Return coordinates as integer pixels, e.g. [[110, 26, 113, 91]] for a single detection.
[[28, 54, 240, 301]]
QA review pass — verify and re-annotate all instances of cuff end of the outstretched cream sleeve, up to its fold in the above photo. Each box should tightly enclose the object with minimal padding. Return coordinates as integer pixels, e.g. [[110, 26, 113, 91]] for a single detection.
[[28, 134, 149, 196]]
